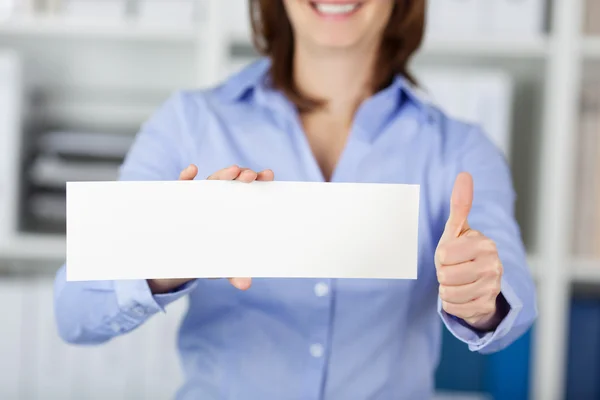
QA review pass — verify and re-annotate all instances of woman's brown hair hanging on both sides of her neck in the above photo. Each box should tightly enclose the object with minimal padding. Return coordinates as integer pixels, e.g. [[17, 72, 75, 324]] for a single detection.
[[250, 0, 425, 111]]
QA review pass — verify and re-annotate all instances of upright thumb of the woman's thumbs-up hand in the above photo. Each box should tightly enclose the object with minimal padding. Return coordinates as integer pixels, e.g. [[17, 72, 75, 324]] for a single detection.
[[442, 172, 473, 240]]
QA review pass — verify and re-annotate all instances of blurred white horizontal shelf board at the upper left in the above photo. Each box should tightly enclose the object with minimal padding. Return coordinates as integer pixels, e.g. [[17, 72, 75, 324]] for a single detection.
[[0, 17, 197, 42]]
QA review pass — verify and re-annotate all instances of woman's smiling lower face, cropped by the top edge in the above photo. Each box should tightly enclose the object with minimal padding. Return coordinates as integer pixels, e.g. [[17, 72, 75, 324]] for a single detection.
[[284, 0, 395, 49]]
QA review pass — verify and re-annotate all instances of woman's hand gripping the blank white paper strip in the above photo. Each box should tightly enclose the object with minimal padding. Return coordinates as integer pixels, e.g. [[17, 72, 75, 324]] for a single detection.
[[148, 164, 274, 294]]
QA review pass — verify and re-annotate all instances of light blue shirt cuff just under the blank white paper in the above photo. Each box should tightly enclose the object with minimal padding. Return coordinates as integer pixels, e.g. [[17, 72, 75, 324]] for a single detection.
[[114, 279, 197, 321]]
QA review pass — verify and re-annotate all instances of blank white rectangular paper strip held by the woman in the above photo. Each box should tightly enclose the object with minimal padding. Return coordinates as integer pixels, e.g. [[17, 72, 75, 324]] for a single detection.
[[67, 180, 419, 281]]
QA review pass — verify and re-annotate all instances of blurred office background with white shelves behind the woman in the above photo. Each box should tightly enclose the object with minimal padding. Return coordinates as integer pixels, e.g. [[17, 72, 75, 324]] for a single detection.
[[0, 0, 600, 400]]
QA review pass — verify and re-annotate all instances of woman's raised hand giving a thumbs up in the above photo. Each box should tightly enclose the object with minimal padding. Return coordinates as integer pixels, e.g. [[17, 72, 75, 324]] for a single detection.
[[435, 172, 503, 330]]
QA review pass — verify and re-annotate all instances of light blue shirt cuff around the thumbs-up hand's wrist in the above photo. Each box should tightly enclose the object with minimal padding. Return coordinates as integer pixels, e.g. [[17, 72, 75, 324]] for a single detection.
[[438, 278, 523, 351]]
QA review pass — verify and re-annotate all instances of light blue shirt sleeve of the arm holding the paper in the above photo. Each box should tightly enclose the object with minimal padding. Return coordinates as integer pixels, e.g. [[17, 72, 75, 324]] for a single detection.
[[54, 94, 197, 344]]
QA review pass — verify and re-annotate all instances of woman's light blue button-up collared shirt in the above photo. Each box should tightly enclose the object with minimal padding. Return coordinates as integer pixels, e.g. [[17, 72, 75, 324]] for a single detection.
[[55, 60, 537, 400]]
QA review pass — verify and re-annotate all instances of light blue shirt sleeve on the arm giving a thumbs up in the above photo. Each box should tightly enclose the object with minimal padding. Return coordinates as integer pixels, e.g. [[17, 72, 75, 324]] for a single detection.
[[438, 122, 537, 354]]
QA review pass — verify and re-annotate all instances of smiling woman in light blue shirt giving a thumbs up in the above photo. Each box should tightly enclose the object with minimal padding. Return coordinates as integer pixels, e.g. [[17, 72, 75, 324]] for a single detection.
[[56, 0, 536, 400]]
